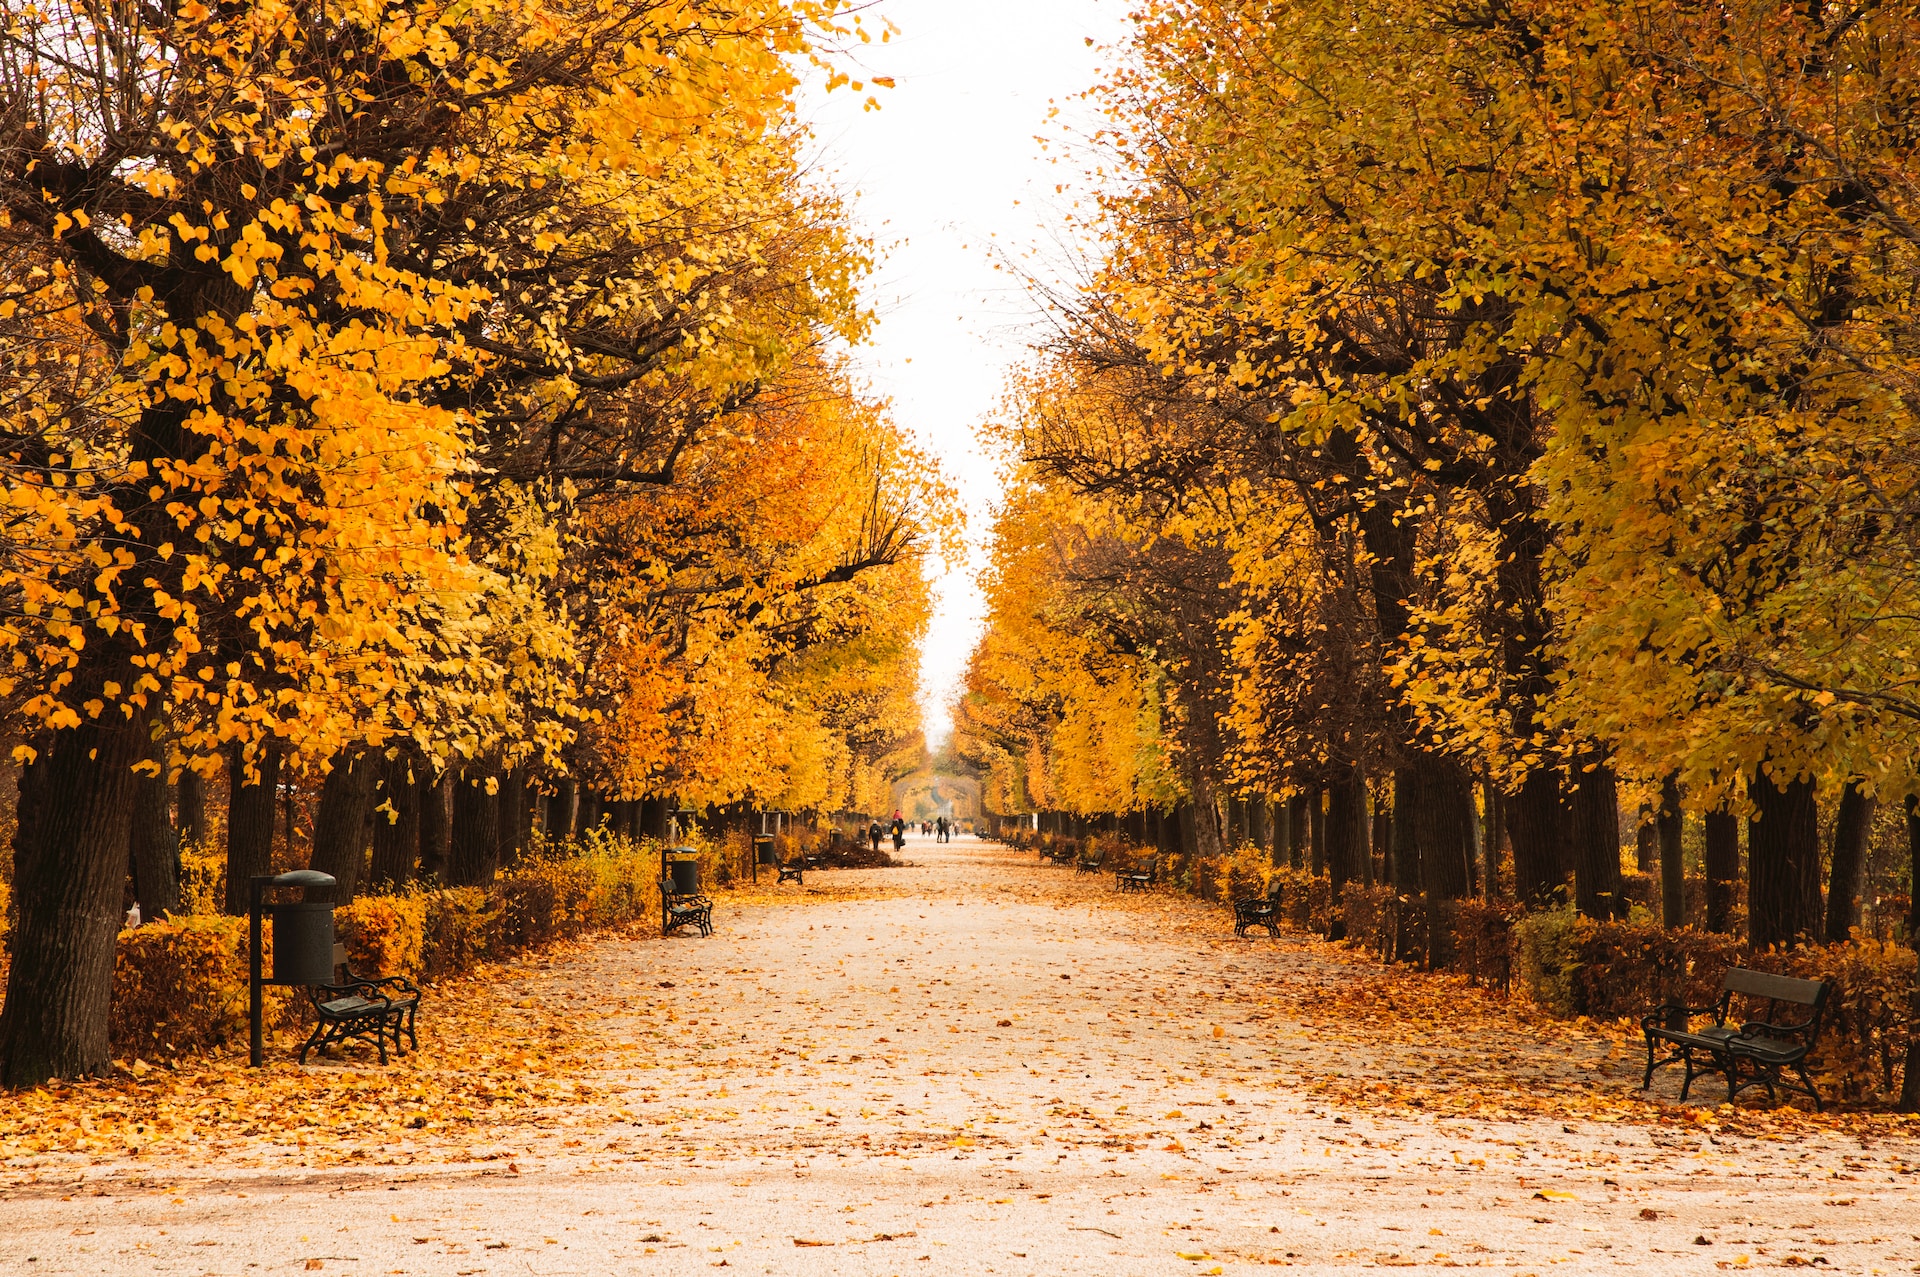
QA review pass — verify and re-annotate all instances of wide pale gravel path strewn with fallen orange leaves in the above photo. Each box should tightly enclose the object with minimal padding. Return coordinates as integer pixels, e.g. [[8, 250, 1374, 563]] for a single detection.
[[0, 841, 1920, 1277]]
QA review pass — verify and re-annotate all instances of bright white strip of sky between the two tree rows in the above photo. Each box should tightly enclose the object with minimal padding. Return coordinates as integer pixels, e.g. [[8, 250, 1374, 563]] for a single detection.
[[803, 0, 1127, 749]]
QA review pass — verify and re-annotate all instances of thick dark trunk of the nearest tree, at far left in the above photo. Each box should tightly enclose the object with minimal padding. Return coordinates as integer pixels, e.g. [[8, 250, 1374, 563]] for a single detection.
[[0, 712, 148, 1087]]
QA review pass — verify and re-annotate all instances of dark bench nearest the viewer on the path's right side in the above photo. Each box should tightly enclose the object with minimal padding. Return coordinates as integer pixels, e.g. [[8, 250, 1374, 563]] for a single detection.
[[1640, 966, 1832, 1112]]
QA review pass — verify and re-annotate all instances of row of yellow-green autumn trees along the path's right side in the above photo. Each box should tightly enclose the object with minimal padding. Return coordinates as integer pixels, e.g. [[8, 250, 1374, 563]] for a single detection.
[[960, 0, 1920, 945]]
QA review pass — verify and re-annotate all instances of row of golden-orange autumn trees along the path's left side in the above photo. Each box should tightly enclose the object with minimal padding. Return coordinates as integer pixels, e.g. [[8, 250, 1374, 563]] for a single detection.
[[0, 0, 933, 1085]]
